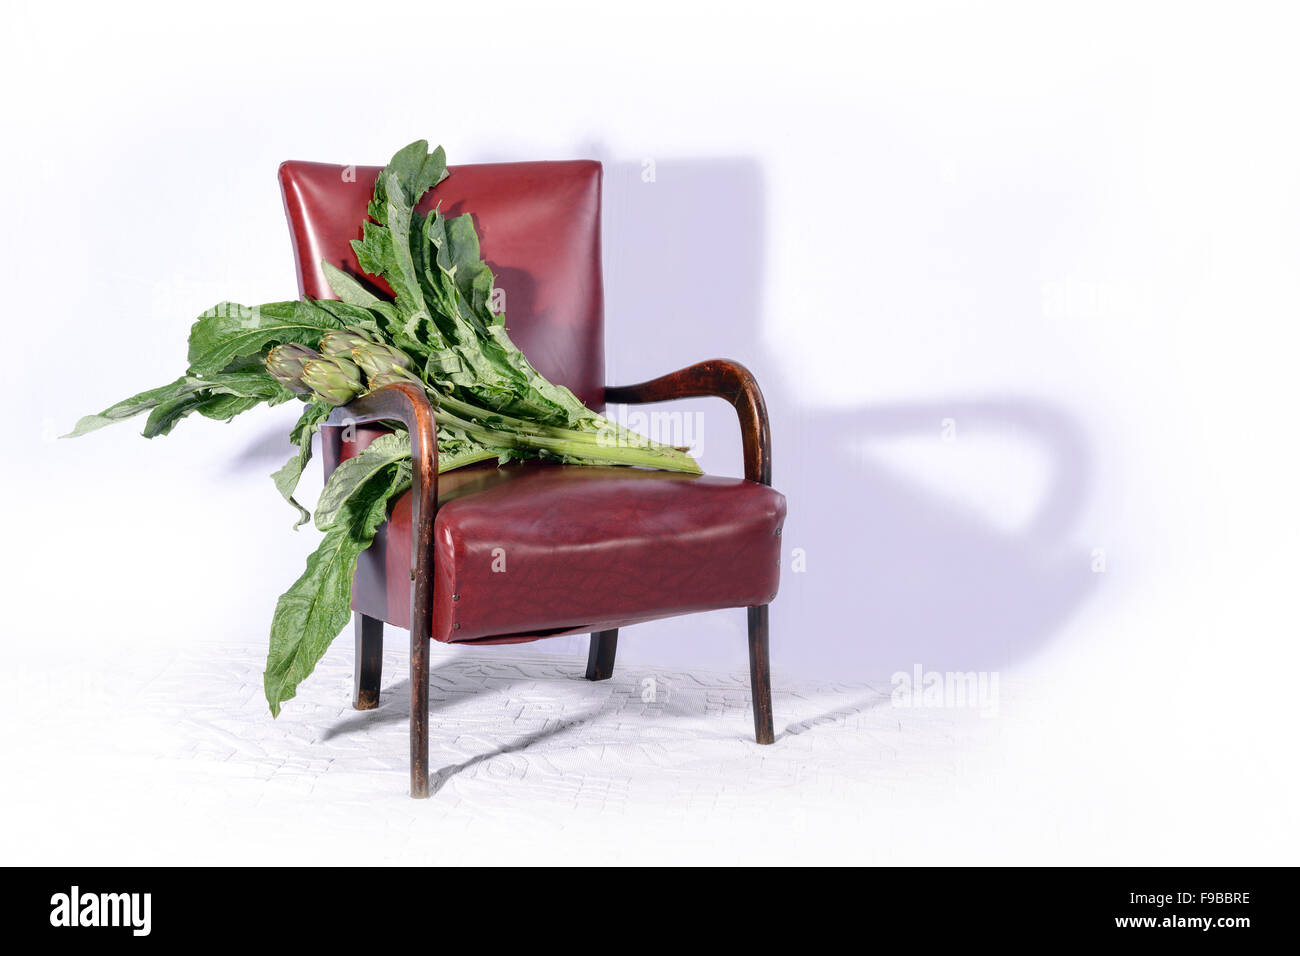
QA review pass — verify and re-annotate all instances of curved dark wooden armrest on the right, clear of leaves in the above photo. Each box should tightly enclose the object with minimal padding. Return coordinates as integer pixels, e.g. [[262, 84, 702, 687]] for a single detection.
[[605, 359, 772, 485]]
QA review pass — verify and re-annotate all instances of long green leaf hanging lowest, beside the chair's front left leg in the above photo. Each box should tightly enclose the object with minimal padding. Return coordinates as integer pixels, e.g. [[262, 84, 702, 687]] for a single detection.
[[264, 455, 411, 717]]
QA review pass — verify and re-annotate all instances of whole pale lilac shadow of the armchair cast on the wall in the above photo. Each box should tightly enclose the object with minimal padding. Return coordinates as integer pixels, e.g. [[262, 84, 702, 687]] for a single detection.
[[597, 150, 1100, 682]]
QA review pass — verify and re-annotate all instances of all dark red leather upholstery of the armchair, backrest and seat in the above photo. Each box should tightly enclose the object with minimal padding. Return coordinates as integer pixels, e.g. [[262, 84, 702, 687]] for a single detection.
[[280, 161, 785, 644]]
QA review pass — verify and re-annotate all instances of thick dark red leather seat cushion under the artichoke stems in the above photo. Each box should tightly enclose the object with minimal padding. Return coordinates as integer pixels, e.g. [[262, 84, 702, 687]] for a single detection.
[[332, 426, 785, 644]]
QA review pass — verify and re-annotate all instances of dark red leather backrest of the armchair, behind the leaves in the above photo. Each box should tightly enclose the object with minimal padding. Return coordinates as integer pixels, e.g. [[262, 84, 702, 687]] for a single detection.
[[280, 160, 605, 408]]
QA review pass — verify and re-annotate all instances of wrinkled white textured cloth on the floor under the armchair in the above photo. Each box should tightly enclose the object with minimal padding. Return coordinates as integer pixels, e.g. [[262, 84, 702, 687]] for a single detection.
[[3, 630, 998, 864]]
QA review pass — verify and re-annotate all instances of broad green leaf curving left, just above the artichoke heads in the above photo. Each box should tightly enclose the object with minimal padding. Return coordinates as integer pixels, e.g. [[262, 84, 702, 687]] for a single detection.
[[190, 300, 343, 375]]
